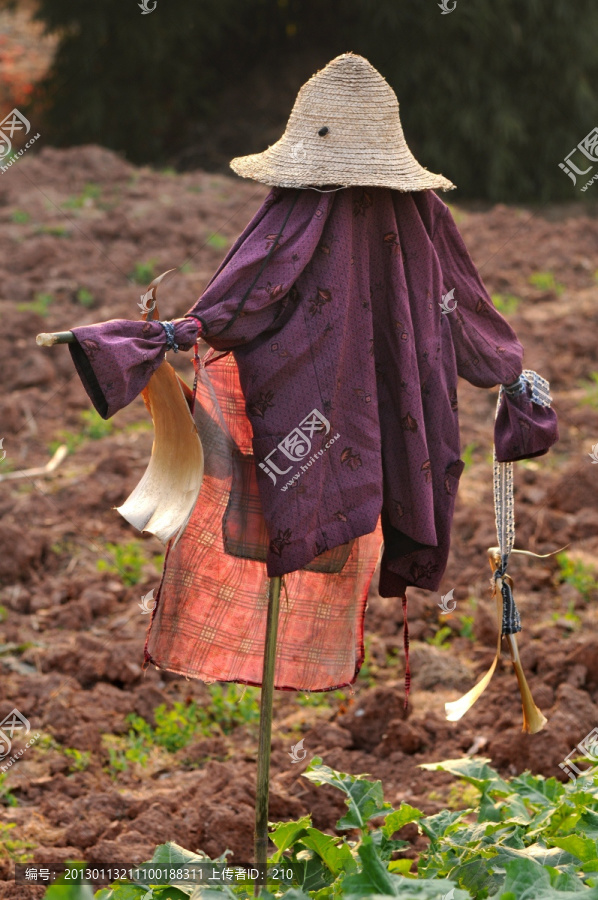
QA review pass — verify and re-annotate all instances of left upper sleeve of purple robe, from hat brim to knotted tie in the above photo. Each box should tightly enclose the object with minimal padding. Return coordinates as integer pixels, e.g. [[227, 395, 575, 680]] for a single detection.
[[187, 188, 333, 350]]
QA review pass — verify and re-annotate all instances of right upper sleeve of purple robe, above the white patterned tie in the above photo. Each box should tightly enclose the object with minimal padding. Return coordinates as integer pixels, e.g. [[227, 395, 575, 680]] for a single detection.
[[433, 198, 523, 388]]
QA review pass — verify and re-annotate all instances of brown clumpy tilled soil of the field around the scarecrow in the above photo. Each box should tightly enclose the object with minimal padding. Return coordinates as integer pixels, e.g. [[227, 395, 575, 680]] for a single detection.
[[0, 147, 598, 900]]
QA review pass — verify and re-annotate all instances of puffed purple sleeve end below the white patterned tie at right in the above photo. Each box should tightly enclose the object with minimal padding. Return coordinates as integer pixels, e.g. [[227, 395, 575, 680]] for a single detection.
[[494, 385, 559, 462]]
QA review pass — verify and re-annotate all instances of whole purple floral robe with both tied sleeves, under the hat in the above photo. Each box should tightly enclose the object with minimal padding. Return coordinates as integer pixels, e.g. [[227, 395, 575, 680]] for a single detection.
[[71, 188, 558, 596]]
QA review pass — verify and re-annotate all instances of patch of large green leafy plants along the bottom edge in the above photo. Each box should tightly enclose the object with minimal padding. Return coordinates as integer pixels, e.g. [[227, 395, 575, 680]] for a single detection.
[[39, 757, 598, 900]]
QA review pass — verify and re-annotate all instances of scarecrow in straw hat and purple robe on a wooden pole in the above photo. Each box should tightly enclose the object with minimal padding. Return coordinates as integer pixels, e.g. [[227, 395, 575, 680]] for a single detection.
[[39, 54, 558, 861]]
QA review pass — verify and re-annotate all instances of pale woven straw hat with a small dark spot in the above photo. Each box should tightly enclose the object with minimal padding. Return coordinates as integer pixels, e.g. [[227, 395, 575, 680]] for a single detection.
[[230, 53, 455, 191]]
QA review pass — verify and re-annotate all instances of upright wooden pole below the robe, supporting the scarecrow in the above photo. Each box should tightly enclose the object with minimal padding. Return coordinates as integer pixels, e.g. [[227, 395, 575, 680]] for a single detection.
[[254, 575, 281, 897]]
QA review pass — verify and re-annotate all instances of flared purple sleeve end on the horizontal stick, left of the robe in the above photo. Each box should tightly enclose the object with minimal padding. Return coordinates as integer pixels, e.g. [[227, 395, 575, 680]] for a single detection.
[[69, 318, 199, 419]]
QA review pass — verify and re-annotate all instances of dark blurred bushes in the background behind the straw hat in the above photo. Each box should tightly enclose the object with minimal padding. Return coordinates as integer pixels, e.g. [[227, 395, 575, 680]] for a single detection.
[[7, 0, 598, 201]]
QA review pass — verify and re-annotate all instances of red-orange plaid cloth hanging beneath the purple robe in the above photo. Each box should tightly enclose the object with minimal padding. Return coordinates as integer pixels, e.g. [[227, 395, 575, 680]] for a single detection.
[[145, 354, 381, 691]]
